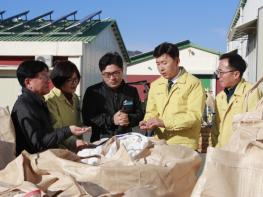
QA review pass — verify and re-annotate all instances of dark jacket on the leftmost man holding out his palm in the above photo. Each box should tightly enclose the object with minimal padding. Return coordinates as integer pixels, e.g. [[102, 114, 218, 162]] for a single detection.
[[11, 88, 72, 155]]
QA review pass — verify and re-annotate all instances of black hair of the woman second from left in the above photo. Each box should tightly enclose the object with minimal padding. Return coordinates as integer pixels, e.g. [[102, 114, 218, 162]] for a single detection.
[[50, 60, 80, 88]]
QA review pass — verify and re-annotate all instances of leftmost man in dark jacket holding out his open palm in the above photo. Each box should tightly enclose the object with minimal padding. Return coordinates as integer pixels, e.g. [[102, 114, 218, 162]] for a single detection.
[[11, 60, 90, 155]]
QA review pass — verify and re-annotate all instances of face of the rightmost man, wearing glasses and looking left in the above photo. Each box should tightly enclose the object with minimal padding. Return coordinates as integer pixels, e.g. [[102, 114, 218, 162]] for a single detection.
[[217, 59, 240, 88]]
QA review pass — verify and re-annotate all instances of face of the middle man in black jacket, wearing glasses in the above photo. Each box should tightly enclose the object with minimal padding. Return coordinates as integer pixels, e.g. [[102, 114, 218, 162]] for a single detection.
[[101, 64, 123, 89]]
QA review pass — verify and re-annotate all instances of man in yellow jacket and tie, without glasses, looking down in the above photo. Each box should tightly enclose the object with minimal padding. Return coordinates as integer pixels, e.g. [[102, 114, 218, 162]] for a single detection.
[[139, 43, 205, 150]]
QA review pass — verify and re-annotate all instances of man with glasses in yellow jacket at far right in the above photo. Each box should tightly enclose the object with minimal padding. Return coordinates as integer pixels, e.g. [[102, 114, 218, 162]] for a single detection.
[[212, 53, 262, 147]]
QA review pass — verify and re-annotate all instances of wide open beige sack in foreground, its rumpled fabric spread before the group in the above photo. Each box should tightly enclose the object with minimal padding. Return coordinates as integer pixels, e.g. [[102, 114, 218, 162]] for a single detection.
[[0, 139, 200, 197]]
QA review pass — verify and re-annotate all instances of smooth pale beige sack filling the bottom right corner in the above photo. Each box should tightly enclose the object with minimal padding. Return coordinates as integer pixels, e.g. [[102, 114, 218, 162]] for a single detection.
[[191, 147, 263, 197]]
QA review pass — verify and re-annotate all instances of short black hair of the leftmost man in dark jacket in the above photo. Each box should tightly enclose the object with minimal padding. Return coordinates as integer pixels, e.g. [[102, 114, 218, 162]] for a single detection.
[[16, 60, 48, 87]]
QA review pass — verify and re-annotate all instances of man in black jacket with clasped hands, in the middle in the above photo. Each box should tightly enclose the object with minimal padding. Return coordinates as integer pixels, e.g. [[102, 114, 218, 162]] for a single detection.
[[82, 52, 143, 141]]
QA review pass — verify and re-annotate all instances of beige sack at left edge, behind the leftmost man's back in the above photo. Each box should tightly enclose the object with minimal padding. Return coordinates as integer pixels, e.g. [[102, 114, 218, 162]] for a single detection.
[[0, 107, 15, 170]]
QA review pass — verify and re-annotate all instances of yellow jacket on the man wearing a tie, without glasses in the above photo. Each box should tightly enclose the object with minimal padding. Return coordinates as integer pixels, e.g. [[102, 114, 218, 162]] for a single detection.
[[144, 68, 205, 149]]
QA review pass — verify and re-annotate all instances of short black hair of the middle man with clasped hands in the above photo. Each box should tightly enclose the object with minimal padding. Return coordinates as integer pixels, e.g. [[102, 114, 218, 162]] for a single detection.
[[99, 52, 123, 72]]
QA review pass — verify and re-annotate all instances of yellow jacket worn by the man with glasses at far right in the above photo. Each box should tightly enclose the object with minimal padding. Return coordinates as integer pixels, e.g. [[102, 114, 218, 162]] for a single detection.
[[212, 79, 262, 147]]
